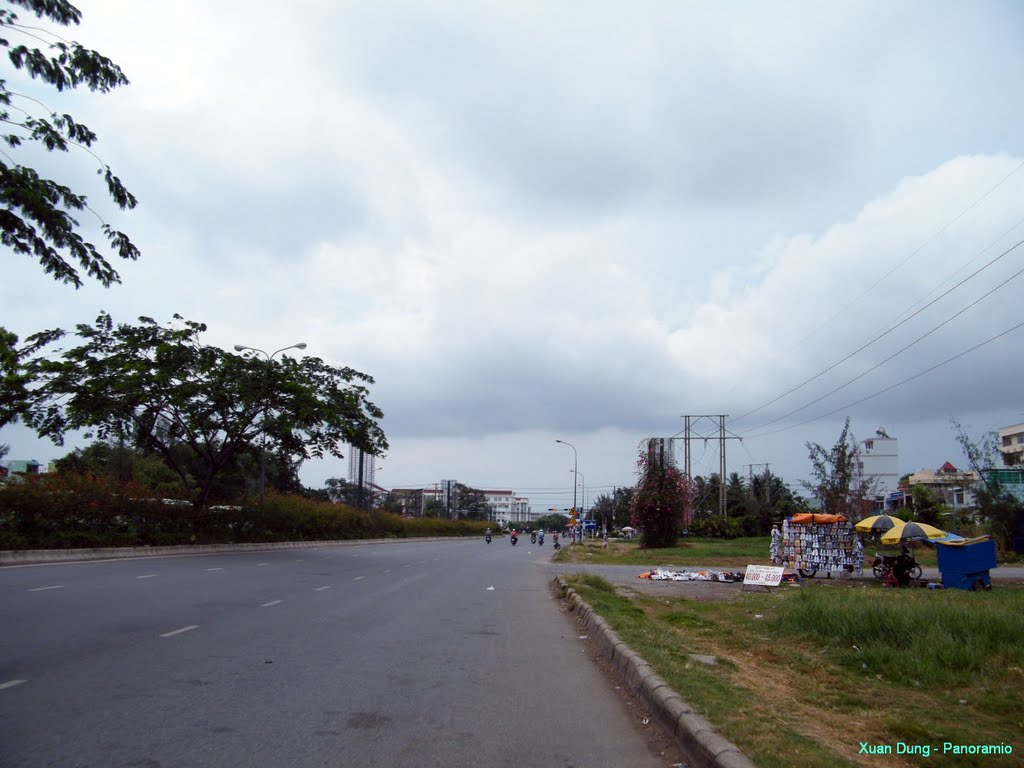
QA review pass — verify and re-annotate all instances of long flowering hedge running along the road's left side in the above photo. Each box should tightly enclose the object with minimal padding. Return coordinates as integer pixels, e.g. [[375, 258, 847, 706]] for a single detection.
[[0, 474, 488, 550]]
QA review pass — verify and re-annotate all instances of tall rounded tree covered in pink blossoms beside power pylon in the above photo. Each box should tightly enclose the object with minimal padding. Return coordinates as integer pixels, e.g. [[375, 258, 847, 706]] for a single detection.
[[632, 439, 693, 549]]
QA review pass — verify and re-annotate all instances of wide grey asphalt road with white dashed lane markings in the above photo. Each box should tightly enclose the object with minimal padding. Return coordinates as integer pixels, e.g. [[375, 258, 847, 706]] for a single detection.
[[0, 539, 674, 768]]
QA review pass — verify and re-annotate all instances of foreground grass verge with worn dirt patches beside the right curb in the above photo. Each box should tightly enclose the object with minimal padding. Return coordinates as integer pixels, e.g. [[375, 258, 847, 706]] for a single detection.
[[567, 575, 1024, 768]]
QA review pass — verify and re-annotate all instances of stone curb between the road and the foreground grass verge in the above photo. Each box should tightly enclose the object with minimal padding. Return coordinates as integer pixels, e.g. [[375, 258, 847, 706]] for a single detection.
[[555, 577, 757, 768]]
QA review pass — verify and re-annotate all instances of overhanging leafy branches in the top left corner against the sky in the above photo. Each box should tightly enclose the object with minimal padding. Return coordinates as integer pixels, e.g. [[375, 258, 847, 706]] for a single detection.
[[0, 0, 139, 288]]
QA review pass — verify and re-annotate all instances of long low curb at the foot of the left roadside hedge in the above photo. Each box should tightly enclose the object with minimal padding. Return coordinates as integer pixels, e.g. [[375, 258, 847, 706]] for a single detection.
[[0, 537, 456, 567]]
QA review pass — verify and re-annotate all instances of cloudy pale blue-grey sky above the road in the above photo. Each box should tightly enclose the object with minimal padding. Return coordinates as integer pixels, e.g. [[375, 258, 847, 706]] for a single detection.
[[0, 0, 1024, 518]]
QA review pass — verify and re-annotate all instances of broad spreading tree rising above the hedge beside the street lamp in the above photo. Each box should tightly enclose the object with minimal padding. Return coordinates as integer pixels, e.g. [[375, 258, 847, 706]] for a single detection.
[[25, 312, 387, 507]]
